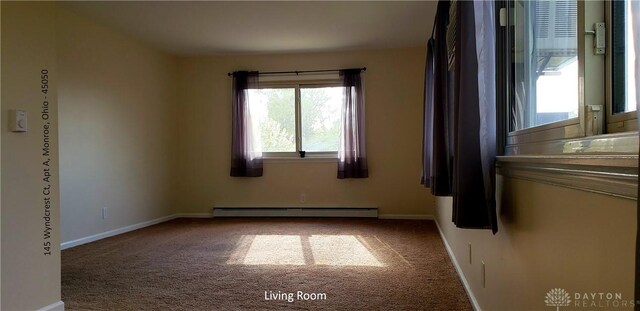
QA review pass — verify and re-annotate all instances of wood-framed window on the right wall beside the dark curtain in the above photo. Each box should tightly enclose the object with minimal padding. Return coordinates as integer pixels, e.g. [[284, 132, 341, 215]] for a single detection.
[[498, 0, 640, 155]]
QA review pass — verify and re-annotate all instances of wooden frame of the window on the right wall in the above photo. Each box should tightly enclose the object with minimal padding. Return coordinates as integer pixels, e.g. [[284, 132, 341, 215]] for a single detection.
[[496, 0, 638, 156]]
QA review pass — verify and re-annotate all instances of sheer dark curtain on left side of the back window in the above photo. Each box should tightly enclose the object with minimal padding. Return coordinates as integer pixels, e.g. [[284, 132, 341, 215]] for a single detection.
[[231, 71, 262, 177]]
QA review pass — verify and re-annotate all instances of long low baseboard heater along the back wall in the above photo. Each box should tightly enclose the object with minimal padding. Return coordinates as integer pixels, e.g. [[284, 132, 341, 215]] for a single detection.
[[213, 207, 378, 218]]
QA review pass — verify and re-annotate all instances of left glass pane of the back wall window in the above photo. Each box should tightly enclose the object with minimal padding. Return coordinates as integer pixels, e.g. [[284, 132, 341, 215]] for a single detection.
[[249, 88, 296, 152]]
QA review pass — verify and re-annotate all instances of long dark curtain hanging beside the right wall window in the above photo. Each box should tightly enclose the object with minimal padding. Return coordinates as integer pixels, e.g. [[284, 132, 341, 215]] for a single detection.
[[423, 1, 498, 233]]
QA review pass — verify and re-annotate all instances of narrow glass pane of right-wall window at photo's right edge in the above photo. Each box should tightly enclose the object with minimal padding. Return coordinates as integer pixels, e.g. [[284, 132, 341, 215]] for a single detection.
[[611, 0, 638, 114]]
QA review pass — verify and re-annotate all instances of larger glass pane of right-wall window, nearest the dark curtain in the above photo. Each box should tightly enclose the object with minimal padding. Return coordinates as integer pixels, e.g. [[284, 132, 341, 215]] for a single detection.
[[510, 1, 579, 131]]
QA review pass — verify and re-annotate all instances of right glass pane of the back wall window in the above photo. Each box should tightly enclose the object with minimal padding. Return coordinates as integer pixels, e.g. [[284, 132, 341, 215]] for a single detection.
[[300, 87, 344, 152]]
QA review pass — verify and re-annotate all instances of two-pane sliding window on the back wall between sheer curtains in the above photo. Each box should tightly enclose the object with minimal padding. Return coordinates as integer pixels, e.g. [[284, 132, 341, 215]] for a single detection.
[[250, 82, 344, 158]]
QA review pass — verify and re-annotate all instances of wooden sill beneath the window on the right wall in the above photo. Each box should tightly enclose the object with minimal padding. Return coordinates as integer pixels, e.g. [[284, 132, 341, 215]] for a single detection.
[[496, 154, 638, 200]]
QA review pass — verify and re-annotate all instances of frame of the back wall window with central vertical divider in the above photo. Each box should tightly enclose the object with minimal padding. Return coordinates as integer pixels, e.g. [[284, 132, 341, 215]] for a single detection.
[[259, 77, 342, 160]]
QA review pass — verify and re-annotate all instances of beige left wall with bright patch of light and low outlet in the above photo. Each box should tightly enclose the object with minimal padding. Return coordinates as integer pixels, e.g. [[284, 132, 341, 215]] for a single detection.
[[56, 9, 176, 242]]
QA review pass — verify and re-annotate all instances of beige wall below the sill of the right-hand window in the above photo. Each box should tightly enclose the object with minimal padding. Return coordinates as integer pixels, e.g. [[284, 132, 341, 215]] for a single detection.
[[436, 177, 636, 310]]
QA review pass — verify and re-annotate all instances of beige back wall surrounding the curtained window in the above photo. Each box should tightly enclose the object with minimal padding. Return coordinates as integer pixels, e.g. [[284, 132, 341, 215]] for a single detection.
[[175, 48, 433, 215]]
